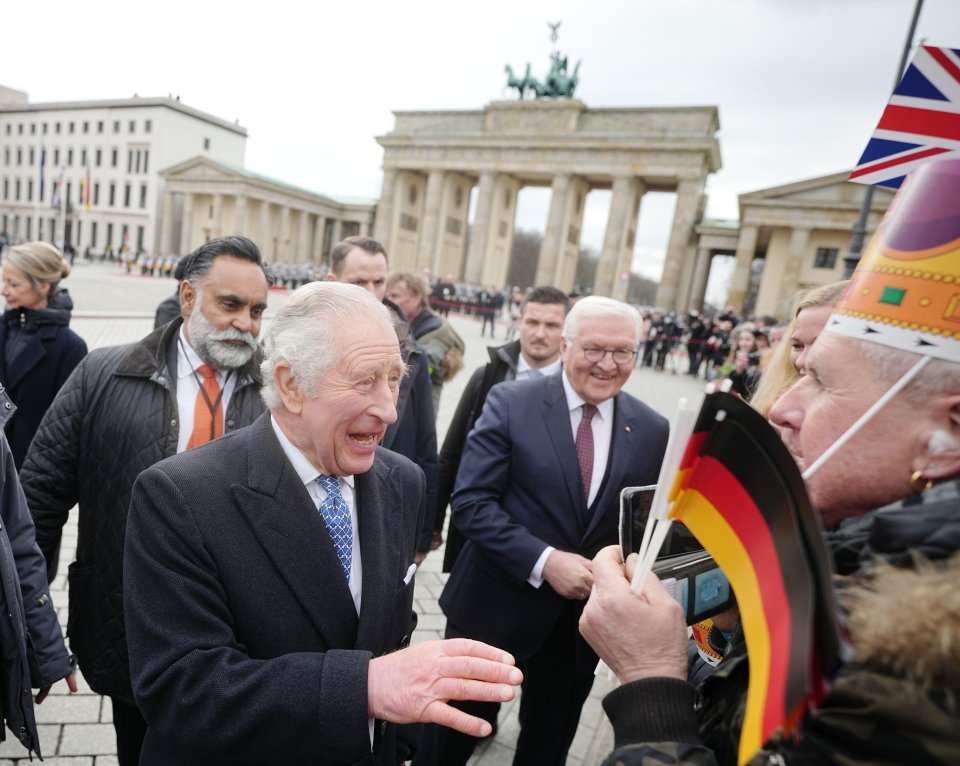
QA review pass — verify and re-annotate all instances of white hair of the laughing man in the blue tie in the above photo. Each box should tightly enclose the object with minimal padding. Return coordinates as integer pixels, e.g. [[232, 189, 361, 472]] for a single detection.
[[260, 282, 393, 410]]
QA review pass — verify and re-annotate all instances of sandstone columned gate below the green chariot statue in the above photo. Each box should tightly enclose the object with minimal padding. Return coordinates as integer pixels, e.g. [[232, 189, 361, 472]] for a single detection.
[[374, 99, 720, 308]]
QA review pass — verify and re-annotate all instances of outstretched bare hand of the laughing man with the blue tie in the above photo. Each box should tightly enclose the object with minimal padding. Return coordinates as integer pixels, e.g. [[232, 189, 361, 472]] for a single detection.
[[367, 638, 523, 737]]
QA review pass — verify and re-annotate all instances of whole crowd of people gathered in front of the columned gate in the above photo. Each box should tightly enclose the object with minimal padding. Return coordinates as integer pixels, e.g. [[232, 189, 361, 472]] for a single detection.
[[0, 156, 960, 766]]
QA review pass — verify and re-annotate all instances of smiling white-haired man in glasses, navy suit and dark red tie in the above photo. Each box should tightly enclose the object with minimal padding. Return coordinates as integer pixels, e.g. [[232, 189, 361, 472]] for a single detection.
[[416, 296, 667, 766]]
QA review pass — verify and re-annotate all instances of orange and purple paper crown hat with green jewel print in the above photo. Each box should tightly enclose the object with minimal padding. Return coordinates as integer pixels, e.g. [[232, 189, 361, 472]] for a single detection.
[[827, 160, 960, 362]]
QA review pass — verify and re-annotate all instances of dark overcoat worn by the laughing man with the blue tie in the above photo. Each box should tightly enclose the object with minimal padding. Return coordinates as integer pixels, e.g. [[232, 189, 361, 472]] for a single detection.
[[124, 413, 424, 766]]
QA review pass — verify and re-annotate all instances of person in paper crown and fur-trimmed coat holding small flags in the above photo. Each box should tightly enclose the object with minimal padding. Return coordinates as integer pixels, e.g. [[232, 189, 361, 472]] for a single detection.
[[580, 160, 960, 766]]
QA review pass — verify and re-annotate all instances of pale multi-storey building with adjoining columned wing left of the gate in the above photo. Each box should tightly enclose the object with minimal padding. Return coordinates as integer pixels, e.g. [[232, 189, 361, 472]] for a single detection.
[[0, 86, 376, 263]]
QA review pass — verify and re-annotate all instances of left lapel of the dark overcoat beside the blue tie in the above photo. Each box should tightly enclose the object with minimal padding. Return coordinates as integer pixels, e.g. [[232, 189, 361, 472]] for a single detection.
[[233, 412, 366, 649]]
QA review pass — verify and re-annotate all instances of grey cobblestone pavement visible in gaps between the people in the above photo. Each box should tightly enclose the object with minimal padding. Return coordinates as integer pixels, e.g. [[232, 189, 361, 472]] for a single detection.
[[0, 263, 702, 766]]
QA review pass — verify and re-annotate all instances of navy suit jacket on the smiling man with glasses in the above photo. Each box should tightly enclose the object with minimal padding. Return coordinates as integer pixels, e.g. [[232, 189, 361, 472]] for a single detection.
[[440, 371, 668, 660]]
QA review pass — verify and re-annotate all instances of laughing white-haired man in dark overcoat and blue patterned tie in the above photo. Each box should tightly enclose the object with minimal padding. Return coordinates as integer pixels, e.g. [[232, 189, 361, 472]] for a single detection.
[[124, 282, 521, 766]]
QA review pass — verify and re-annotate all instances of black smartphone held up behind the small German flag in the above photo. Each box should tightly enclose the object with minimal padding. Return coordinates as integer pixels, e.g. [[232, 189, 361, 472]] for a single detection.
[[620, 485, 736, 625]]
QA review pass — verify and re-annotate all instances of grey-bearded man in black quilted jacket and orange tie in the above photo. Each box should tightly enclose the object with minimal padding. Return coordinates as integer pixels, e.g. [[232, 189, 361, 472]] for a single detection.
[[21, 237, 268, 766]]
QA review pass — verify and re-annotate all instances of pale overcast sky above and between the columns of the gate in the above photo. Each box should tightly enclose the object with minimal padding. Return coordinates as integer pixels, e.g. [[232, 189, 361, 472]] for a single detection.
[[0, 0, 960, 296]]
